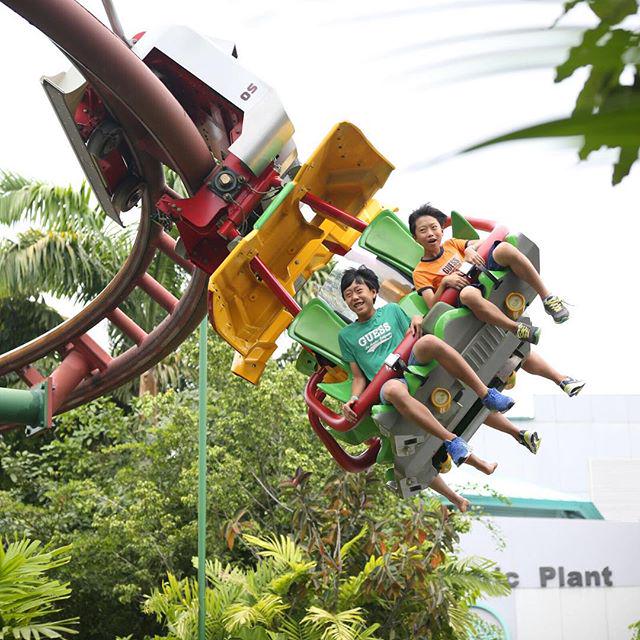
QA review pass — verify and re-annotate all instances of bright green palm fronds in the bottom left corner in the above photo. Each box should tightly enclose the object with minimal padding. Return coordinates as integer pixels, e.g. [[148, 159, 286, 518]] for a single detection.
[[0, 537, 76, 640]]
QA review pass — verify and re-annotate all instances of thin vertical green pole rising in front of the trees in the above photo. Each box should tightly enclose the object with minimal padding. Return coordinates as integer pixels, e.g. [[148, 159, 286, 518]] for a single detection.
[[198, 316, 207, 640]]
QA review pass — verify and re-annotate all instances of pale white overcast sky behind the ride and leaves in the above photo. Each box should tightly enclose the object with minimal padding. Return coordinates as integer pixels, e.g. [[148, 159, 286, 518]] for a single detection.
[[0, 0, 640, 393]]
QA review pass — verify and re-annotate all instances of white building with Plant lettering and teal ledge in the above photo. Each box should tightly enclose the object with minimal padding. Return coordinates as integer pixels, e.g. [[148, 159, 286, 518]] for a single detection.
[[447, 395, 640, 640]]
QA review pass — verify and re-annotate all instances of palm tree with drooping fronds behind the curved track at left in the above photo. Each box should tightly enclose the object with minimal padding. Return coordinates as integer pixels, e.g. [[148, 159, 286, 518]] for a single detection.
[[0, 172, 186, 400]]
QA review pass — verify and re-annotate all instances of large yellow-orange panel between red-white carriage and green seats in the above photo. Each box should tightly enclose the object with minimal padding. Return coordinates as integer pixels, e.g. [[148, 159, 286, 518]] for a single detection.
[[209, 122, 393, 384]]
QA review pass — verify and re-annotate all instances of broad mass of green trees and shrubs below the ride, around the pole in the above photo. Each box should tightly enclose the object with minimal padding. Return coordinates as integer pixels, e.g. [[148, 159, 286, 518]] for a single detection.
[[0, 330, 507, 640]]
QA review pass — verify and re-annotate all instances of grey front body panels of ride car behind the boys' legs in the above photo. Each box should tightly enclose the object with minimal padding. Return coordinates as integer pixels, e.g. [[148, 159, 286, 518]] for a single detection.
[[374, 234, 540, 498]]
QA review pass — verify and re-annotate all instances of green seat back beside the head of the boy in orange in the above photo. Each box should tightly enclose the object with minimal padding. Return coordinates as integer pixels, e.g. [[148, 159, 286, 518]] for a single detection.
[[359, 209, 423, 278]]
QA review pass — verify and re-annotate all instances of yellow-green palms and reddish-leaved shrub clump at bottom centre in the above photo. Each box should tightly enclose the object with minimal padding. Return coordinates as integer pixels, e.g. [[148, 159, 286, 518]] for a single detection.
[[144, 473, 509, 640]]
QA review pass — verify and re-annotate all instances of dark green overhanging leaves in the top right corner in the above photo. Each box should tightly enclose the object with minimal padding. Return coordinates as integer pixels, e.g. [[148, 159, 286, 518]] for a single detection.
[[466, 0, 640, 185]]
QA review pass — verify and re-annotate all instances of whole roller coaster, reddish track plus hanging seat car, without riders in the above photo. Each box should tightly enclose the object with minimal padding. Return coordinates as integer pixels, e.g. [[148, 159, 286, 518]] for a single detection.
[[0, 0, 539, 496]]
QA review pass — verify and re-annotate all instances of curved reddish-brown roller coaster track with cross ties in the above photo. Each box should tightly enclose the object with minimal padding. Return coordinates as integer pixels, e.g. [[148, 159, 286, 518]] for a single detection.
[[0, 0, 214, 431]]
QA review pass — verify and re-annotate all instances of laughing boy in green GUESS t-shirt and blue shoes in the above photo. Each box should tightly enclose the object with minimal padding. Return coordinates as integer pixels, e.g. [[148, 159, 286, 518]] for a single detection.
[[338, 266, 514, 474]]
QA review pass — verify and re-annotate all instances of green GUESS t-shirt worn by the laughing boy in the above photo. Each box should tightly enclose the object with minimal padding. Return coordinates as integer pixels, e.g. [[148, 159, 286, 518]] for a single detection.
[[338, 302, 411, 381]]
